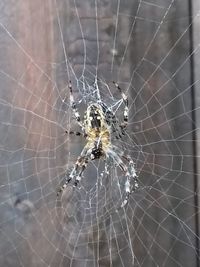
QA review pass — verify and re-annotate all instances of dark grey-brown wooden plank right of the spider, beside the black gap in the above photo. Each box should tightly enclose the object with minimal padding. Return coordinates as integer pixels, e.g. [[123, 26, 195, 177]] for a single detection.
[[132, 1, 199, 266]]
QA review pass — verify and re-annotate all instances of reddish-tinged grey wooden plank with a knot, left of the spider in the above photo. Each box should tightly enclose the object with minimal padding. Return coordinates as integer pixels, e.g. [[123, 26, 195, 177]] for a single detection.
[[0, 0, 63, 267]]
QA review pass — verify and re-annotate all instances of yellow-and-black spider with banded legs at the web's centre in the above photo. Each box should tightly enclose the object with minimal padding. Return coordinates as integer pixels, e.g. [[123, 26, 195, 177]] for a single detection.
[[57, 81, 139, 207]]
